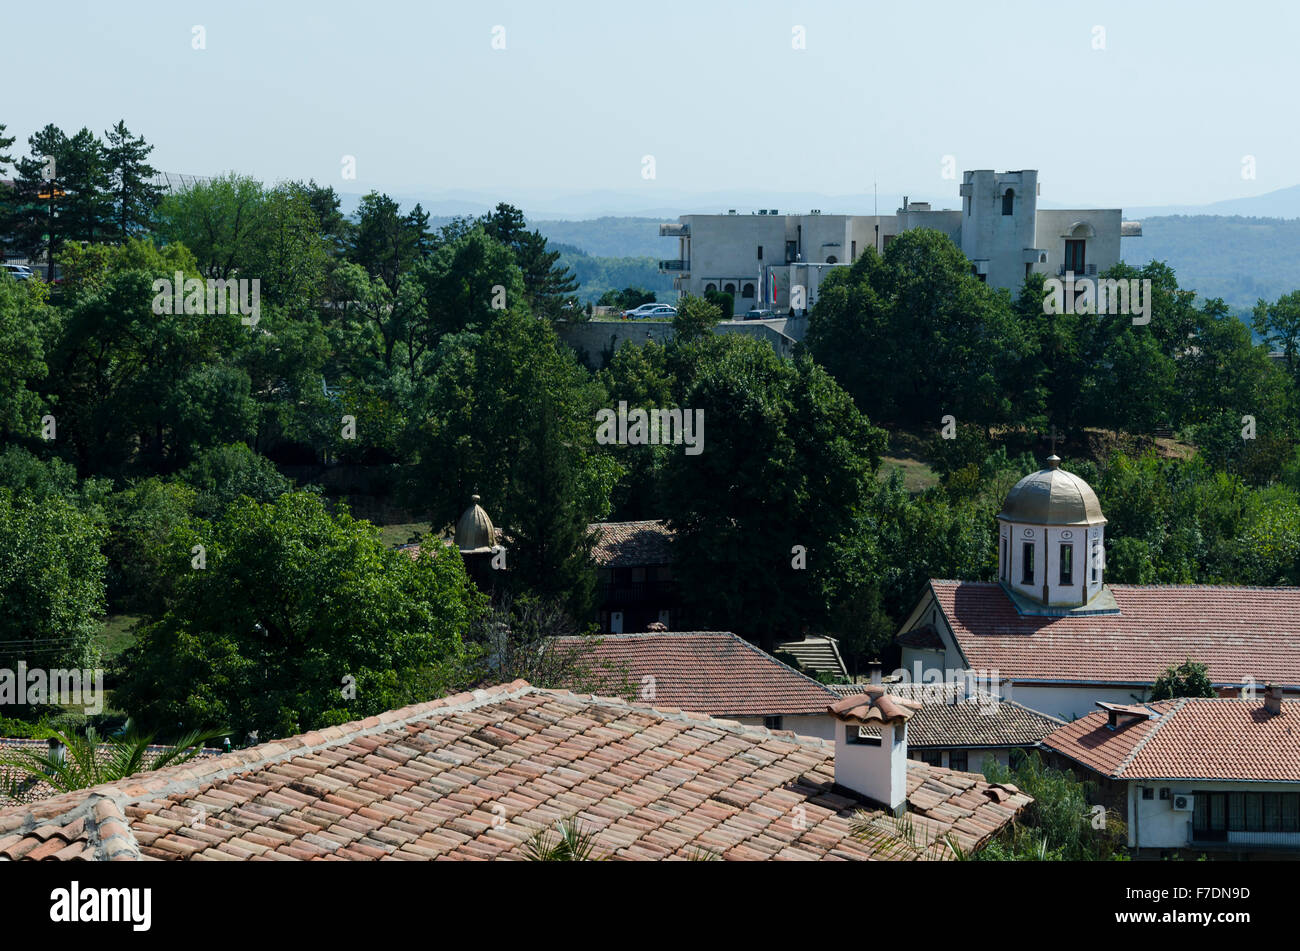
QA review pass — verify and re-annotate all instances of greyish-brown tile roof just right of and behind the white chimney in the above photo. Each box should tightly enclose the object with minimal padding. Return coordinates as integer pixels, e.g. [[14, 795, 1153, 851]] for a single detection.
[[831, 683, 1065, 750]]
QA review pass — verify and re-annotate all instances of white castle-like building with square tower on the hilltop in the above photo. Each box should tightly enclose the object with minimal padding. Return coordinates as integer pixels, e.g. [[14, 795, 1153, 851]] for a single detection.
[[659, 169, 1141, 314]]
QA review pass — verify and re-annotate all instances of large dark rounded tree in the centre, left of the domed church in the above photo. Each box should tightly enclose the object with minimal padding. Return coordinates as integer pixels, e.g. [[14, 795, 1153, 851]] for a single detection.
[[663, 336, 885, 648]]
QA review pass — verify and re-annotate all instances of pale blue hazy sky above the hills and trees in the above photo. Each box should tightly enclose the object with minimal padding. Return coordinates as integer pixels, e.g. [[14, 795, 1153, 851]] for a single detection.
[[0, 0, 1300, 210]]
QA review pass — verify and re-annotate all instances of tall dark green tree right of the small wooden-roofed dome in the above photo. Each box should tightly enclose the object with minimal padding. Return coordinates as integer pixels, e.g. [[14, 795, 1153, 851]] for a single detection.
[[407, 308, 616, 617]]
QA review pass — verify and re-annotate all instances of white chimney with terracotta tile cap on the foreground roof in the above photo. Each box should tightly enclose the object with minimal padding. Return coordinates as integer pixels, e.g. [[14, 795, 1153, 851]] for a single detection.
[[827, 685, 918, 816]]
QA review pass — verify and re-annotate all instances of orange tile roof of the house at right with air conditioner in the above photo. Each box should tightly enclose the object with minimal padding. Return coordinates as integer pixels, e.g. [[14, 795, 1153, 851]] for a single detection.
[[1043, 698, 1300, 782]]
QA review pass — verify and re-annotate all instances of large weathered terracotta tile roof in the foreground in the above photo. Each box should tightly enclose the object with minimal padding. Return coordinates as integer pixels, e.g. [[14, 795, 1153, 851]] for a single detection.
[[0, 681, 1030, 861]]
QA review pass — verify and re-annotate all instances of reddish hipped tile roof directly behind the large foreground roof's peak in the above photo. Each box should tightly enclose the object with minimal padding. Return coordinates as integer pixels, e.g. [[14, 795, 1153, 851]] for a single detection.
[[548, 631, 835, 717]]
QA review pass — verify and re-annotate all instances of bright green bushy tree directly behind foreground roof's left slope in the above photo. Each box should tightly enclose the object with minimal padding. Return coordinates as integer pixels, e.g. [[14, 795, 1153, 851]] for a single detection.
[[117, 492, 484, 738]]
